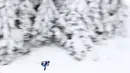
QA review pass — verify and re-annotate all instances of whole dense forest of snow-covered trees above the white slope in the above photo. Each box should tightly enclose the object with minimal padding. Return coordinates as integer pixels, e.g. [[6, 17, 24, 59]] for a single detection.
[[0, 0, 127, 65]]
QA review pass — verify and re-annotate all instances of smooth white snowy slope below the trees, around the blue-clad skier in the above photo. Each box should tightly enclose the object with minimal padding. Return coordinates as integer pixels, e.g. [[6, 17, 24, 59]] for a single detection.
[[0, 0, 130, 73]]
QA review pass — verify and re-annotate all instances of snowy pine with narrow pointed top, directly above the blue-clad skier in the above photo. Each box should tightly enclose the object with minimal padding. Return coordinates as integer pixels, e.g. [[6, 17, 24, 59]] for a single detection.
[[30, 0, 58, 47]]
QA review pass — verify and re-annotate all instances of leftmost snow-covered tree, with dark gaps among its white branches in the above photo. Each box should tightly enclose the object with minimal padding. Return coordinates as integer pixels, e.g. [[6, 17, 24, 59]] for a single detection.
[[0, 0, 33, 64]]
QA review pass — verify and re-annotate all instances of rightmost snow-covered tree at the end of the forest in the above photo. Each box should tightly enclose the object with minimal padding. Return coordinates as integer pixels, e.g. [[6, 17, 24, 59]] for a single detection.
[[102, 0, 126, 37]]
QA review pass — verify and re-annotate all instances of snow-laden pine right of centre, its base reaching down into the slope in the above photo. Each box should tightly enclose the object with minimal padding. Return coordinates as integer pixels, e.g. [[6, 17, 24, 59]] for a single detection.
[[55, 0, 93, 60]]
